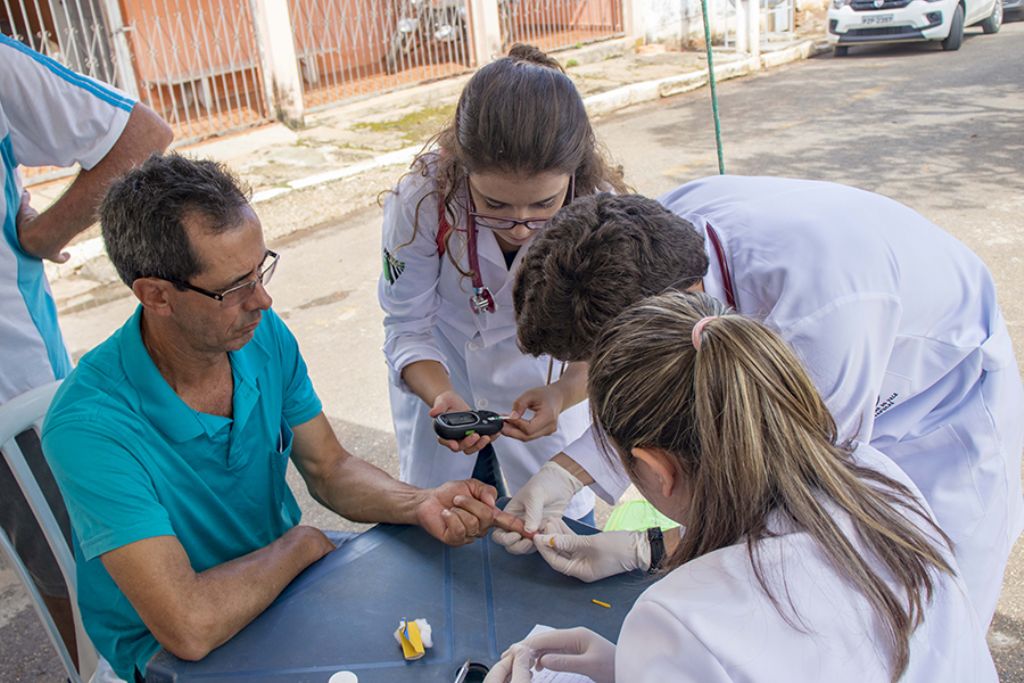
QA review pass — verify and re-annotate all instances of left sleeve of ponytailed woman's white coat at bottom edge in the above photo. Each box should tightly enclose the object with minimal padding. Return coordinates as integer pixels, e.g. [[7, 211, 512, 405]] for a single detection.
[[615, 598, 732, 683]]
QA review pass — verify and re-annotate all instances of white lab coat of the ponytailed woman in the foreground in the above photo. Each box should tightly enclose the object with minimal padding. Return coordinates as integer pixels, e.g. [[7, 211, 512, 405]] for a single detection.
[[615, 446, 997, 683]]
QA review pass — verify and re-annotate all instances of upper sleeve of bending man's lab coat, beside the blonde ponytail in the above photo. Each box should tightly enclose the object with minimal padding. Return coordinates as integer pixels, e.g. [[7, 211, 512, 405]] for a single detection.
[[769, 293, 902, 441]]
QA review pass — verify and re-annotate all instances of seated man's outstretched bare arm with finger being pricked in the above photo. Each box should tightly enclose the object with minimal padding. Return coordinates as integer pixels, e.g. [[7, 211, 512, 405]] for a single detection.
[[292, 413, 521, 545]]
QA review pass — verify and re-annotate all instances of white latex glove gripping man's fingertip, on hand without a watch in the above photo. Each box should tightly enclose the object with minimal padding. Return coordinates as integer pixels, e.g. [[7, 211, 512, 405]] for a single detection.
[[492, 461, 583, 555]]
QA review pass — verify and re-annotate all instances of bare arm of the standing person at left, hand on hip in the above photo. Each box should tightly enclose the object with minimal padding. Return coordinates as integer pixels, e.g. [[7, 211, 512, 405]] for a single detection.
[[17, 103, 173, 263]]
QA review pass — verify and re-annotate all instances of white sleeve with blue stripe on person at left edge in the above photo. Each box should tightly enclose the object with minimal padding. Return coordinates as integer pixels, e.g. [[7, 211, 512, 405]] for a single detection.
[[0, 36, 135, 169]]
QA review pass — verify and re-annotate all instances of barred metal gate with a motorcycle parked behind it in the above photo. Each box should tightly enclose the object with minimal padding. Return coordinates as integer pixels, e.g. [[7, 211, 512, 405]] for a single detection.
[[289, 0, 474, 109]]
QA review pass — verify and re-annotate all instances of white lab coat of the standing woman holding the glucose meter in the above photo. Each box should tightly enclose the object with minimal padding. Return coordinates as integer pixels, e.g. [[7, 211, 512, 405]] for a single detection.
[[378, 156, 596, 517]]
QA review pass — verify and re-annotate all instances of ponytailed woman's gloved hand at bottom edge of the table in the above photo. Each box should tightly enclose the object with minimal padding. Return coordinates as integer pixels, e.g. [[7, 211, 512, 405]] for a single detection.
[[484, 627, 615, 683]]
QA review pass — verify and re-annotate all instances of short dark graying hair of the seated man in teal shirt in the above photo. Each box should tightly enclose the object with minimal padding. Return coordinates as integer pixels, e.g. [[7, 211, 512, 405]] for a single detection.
[[99, 155, 249, 287]]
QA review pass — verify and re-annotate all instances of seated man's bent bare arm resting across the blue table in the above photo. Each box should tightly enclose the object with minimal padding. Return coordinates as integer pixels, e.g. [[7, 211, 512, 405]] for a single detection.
[[100, 526, 334, 660]]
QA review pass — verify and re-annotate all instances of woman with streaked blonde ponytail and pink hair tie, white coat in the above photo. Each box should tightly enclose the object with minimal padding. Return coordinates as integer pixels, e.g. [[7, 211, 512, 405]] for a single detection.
[[486, 293, 996, 683]]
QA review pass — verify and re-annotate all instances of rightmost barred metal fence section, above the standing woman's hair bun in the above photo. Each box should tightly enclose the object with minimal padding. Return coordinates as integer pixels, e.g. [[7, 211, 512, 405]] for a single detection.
[[498, 0, 623, 50]]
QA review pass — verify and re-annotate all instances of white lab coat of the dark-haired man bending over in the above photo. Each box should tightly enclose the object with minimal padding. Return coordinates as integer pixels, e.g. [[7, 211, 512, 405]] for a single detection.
[[567, 176, 1024, 627]]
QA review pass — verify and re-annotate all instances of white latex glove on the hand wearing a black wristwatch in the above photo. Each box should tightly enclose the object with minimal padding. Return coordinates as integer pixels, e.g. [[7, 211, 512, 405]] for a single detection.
[[534, 519, 650, 584]]
